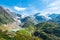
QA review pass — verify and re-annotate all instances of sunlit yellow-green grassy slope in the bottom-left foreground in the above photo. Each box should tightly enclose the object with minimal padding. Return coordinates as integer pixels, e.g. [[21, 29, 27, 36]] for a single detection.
[[0, 27, 41, 40]]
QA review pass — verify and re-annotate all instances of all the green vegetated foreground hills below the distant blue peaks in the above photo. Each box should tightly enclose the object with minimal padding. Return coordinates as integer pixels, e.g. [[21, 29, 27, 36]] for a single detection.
[[0, 22, 60, 40]]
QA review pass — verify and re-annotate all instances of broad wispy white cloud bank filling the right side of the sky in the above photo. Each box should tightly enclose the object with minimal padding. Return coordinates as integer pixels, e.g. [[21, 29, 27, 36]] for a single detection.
[[38, 0, 60, 18]]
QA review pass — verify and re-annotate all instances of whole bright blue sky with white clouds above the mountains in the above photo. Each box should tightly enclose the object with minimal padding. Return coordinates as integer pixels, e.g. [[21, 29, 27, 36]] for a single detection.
[[0, 0, 60, 16]]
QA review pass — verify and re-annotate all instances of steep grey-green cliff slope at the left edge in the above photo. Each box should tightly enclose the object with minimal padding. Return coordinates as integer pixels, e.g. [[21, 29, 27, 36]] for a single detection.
[[0, 6, 13, 24]]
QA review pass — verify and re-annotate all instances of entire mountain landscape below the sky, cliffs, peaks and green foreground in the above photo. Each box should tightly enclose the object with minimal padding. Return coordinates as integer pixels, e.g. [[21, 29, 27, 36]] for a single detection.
[[0, 6, 60, 40]]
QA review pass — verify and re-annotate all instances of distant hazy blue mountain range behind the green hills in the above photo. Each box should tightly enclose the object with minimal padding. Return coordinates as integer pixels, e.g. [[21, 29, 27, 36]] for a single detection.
[[17, 13, 60, 24]]
